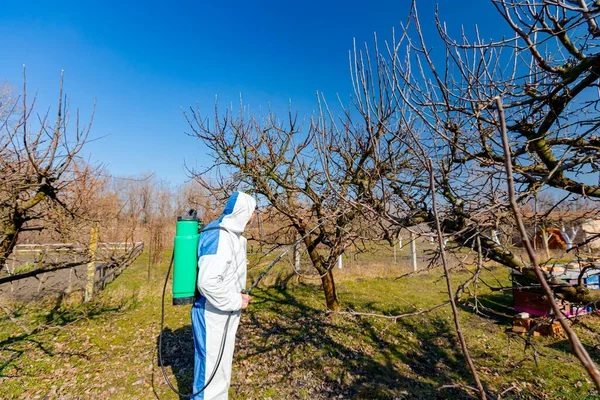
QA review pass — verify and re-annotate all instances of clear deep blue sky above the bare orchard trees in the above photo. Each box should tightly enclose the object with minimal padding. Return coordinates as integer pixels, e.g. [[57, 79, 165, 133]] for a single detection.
[[0, 0, 504, 185]]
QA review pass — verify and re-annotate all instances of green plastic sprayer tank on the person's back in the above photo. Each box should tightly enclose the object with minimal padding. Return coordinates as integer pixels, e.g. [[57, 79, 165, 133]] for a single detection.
[[173, 210, 202, 305]]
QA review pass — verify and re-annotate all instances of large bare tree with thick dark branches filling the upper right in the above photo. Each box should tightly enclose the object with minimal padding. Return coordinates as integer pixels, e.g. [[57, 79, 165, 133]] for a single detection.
[[322, 0, 600, 303]]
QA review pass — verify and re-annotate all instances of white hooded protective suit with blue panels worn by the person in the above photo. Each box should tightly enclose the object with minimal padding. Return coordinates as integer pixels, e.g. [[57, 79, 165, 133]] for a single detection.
[[192, 192, 256, 399]]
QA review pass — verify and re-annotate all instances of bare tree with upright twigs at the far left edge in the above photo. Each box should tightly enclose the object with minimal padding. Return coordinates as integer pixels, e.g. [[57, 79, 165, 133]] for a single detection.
[[0, 74, 97, 265]]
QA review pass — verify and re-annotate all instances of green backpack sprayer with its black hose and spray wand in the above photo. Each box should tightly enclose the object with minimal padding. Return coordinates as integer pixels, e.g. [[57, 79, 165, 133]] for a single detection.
[[158, 210, 325, 398]]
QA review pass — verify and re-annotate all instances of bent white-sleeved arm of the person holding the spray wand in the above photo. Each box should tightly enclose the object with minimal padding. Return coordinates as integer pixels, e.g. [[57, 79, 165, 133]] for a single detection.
[[198, 251, 242, 311]]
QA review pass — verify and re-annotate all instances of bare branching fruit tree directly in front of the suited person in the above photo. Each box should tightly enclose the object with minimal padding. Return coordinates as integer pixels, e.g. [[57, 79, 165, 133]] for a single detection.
[[186, 107, 382, 311]]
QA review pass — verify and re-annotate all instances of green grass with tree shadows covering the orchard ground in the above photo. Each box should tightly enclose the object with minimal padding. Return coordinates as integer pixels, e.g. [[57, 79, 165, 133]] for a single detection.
[[0, 247, 600, 399]]
